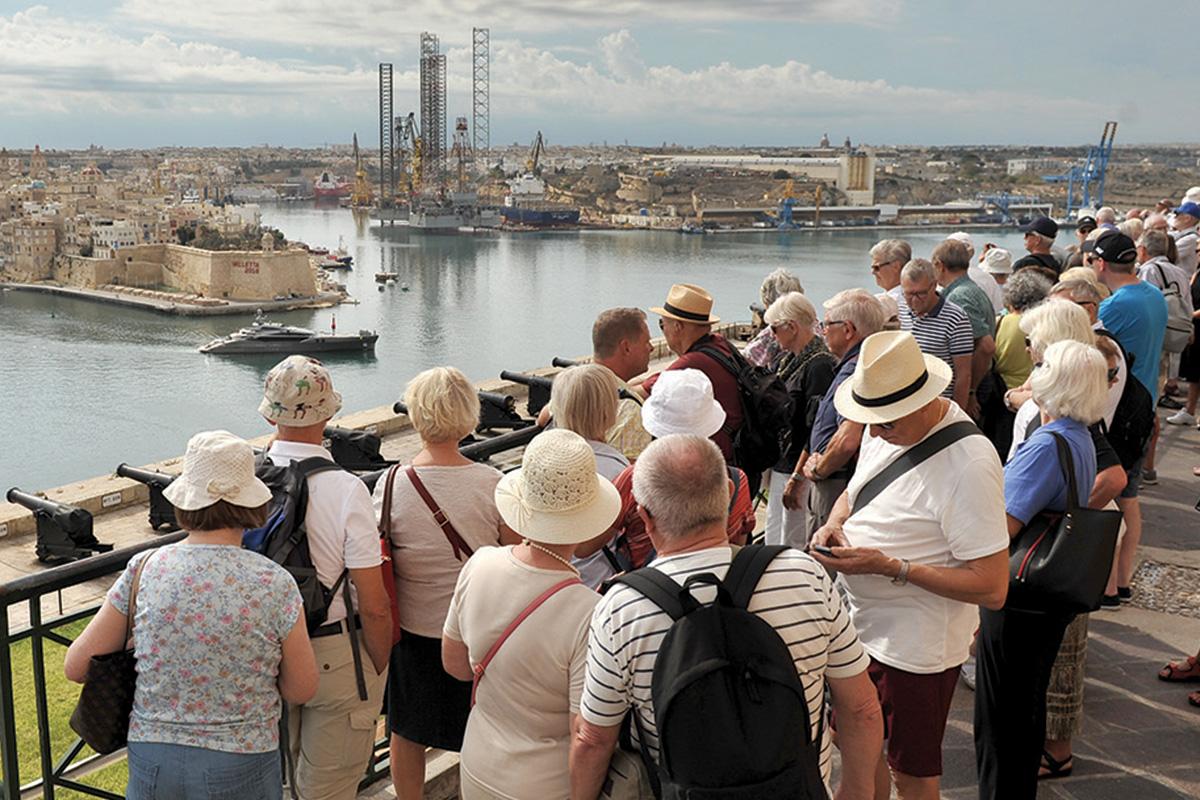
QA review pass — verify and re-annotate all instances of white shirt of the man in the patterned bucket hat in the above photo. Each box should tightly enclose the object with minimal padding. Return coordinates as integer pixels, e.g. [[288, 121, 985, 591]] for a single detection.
[[266, 441, 383, 624]]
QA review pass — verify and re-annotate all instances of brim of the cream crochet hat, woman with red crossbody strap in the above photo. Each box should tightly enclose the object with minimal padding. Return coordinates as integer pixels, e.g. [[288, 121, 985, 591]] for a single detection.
[[496, 469, 620, 545]]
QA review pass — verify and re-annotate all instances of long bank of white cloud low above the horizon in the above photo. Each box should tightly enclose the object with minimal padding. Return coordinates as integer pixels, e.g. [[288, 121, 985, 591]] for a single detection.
[[0, 7, 1105, 144]]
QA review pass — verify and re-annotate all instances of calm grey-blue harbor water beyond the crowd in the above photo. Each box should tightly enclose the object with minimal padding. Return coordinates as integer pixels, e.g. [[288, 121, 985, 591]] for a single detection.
[[0, 204, 1022, 491]]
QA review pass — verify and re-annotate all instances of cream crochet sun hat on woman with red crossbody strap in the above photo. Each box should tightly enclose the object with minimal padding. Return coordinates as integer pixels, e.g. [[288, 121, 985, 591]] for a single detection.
[[496, 428, 620, 545]]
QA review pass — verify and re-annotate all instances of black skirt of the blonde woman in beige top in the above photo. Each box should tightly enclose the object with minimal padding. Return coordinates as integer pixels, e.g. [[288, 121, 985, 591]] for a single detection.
[[388, 631, 470, 752]]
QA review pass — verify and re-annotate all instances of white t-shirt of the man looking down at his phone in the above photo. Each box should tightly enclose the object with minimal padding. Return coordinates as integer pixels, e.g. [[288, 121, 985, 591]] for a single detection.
[[838, 402, 1008, 674]]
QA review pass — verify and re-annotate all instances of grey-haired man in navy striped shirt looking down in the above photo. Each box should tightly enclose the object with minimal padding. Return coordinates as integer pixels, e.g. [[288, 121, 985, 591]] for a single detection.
[[900, 258, 974, 410]]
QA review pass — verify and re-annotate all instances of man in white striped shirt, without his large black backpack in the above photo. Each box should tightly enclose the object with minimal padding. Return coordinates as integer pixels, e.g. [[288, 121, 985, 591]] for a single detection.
[[570, 434, 882, 799]]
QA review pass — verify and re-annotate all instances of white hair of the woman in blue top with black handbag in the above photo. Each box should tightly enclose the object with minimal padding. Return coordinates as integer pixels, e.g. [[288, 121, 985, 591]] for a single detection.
[[1030, 339, 1109, 425]]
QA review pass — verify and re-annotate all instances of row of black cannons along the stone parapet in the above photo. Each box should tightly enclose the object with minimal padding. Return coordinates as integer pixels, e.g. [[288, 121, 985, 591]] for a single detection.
[[6, 359, 588, 565]]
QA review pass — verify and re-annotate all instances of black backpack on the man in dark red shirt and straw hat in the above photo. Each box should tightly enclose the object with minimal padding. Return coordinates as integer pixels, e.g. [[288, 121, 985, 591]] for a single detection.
[[697, 347, 792, 489]]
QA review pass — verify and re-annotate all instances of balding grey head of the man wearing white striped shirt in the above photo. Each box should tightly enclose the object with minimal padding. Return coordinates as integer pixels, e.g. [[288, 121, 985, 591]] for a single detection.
[[634, 433, 730, 539]]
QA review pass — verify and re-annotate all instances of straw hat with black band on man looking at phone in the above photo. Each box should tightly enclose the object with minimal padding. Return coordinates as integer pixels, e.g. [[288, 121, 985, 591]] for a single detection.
[[834, 331, 953, 425]]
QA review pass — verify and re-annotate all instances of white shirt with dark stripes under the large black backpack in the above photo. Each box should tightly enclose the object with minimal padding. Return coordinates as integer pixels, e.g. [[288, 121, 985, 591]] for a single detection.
[[578, 547, 869, 782]]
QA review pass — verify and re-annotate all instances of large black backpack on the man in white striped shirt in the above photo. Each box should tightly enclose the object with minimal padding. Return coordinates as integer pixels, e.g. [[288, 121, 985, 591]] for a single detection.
[[616, 546, 828, 800]]
